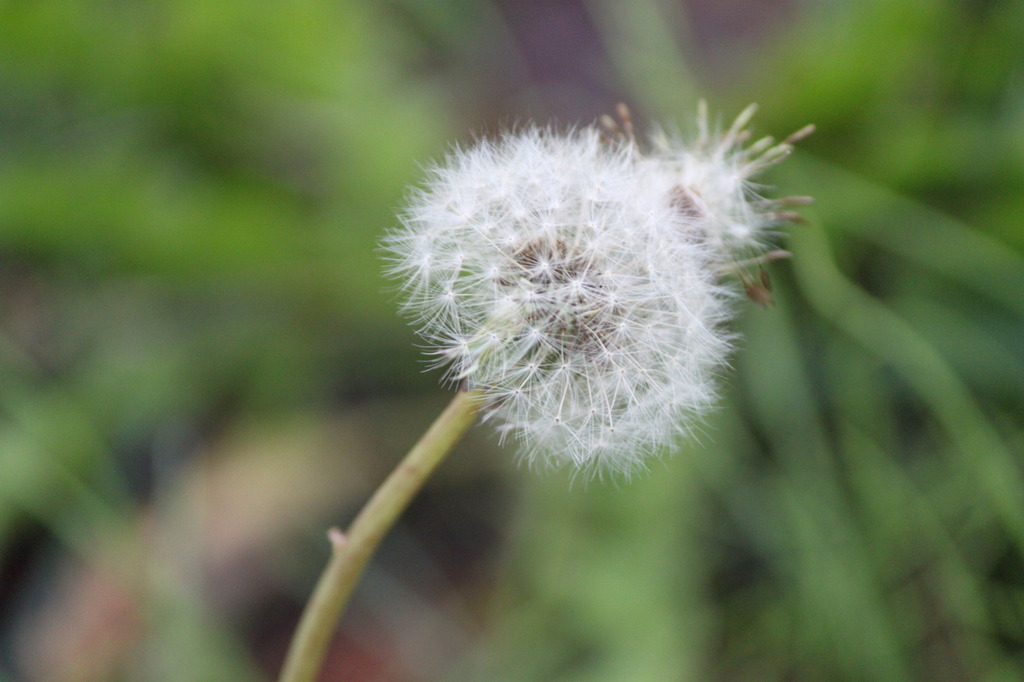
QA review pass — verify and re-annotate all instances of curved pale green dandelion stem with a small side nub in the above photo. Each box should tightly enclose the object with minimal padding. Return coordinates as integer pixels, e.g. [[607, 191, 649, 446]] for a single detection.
[[280, 391, 480, 682]]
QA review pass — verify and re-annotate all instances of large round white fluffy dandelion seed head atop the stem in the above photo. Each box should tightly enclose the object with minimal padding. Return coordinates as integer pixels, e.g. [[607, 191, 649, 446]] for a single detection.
[[384, 107, 806, 474]]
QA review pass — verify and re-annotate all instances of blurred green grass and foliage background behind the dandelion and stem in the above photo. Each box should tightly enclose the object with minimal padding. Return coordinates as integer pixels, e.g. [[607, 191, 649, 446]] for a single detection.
[[0, 0, 1024, 682]]
